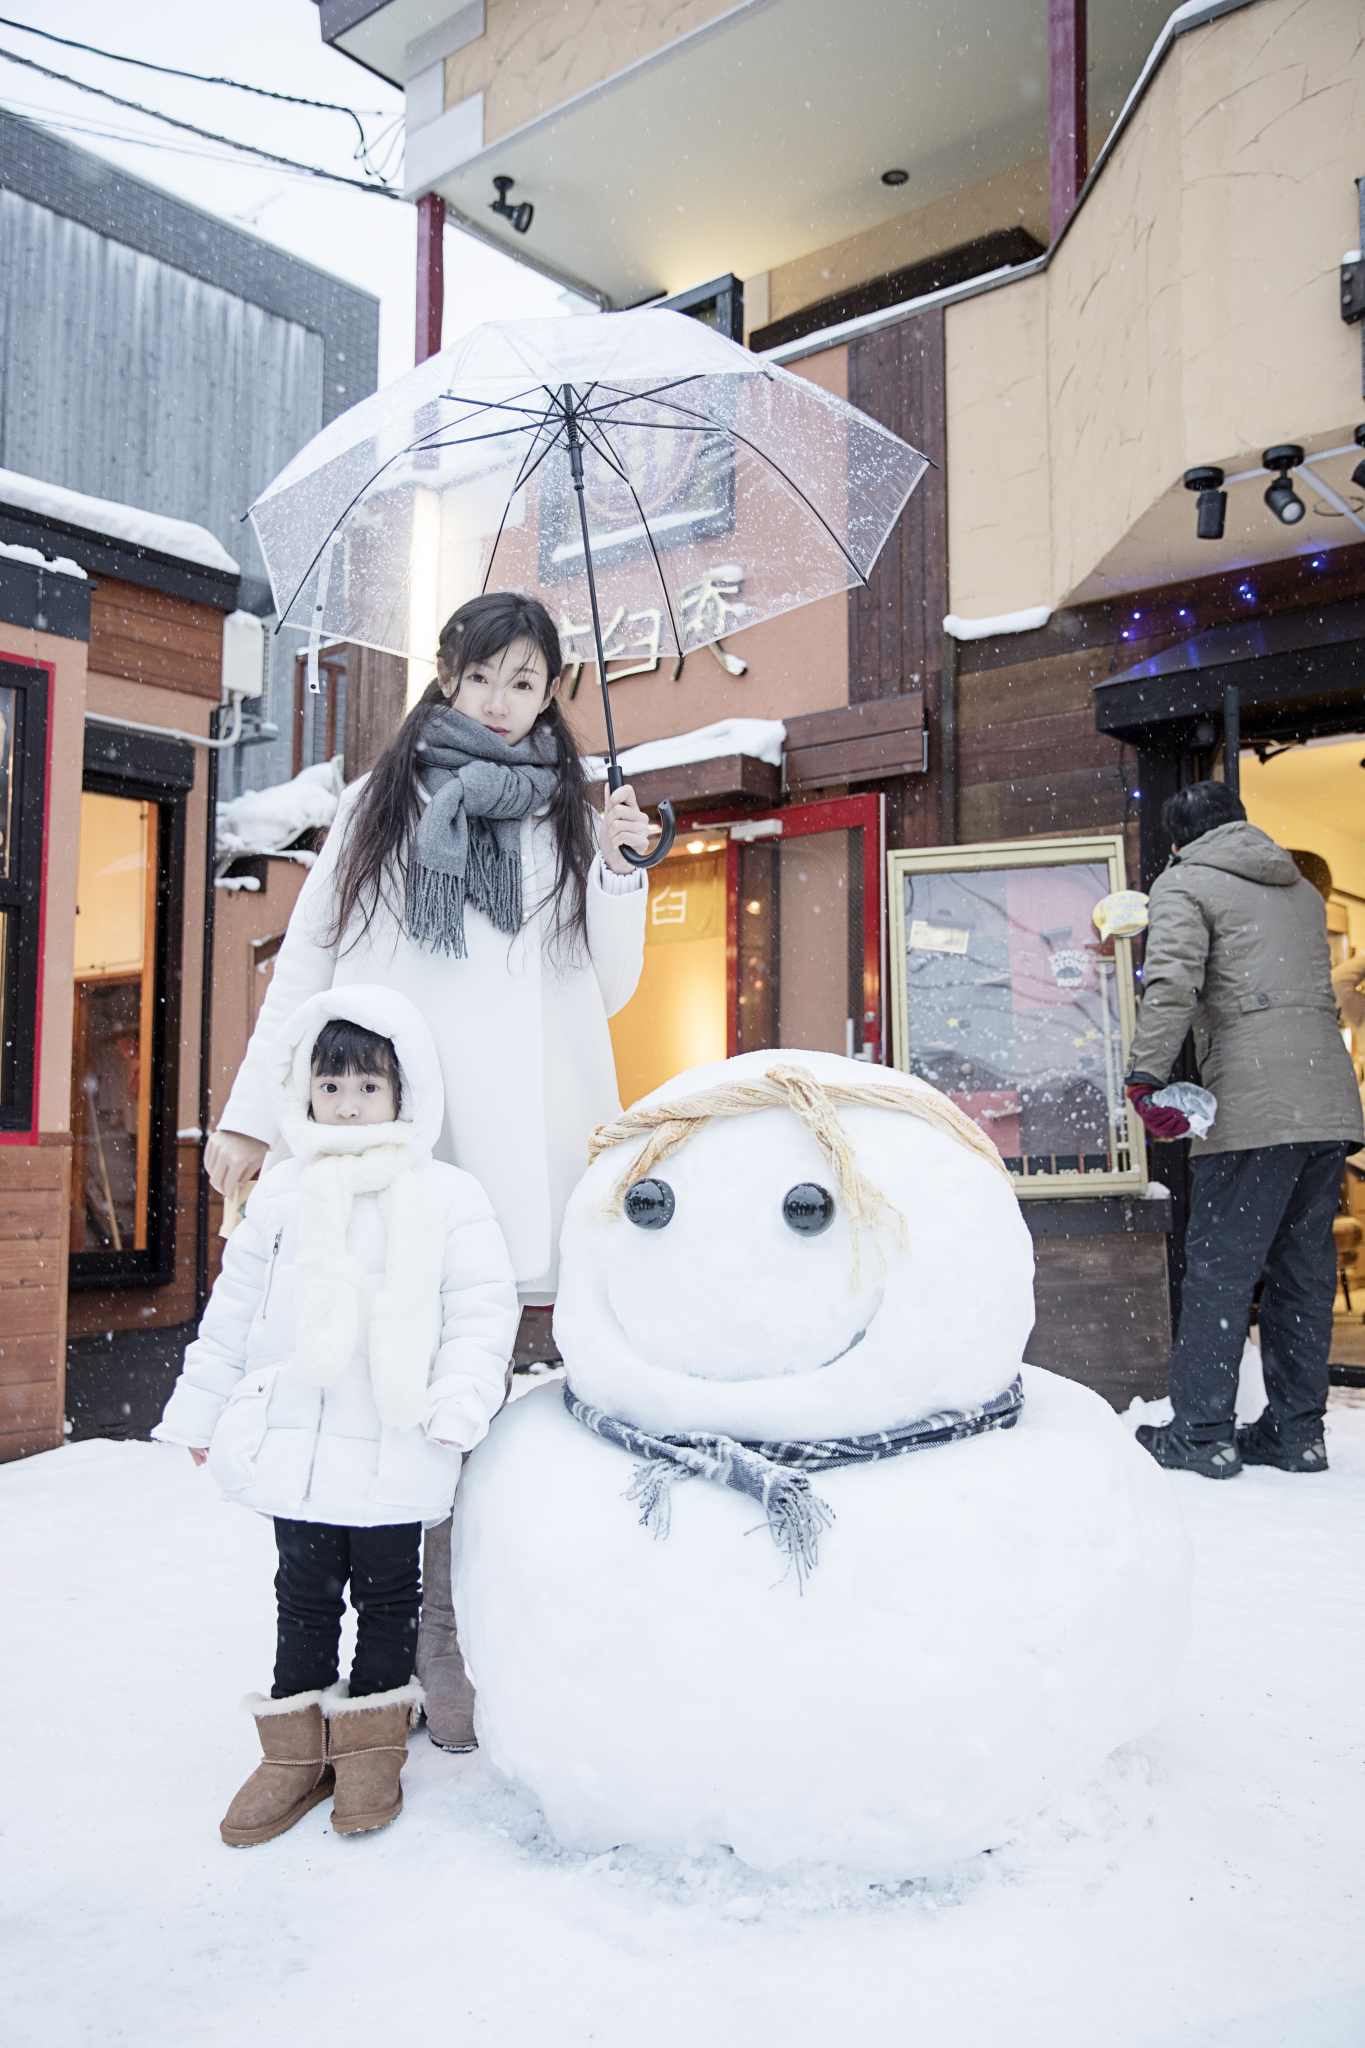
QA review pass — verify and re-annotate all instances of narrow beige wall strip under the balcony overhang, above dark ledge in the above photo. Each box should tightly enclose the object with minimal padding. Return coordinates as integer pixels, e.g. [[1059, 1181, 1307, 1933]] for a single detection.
[[767, 158, 1048, 319]]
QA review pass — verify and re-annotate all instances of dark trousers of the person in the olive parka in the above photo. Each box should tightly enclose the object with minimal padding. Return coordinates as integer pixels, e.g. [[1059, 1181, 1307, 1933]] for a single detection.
[[1171, 1143, 1351, 1450]]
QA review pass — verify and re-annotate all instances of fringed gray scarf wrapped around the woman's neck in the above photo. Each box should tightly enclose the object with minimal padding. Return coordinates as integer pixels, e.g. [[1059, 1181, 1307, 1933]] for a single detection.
[[407, 705, 559, 961]]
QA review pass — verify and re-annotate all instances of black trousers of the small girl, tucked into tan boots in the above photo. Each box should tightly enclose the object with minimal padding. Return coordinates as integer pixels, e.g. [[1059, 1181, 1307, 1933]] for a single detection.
[[270, 1516, 422, 1700]]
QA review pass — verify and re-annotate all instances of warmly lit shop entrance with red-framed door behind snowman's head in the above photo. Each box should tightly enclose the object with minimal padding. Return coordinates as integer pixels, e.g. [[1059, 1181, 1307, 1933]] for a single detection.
[[612, 797, 886, 1106]]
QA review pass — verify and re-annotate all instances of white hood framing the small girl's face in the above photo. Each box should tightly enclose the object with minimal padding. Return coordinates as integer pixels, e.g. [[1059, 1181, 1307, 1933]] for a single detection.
[[270, 983, 446, 1165]]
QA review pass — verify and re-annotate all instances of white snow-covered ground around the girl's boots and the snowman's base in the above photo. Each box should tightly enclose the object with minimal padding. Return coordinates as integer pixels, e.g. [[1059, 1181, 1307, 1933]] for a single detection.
[[0, 1393, 1365, 2048]]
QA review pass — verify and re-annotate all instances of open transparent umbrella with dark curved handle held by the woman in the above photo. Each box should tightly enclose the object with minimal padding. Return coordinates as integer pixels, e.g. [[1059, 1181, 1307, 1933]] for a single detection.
[[252, 311, 927, 866]]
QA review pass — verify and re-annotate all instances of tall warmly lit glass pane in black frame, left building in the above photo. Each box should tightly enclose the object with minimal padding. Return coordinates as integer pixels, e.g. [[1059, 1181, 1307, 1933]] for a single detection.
[[72, 791, 160, 1253]]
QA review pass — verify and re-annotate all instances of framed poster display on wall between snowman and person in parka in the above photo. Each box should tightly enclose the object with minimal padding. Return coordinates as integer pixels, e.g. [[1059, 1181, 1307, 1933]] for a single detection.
[[886, 834, 1146, 1200]]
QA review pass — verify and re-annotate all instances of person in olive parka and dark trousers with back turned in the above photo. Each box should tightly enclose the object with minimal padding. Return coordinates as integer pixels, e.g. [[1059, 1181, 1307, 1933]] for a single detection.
[[1128, 782, 1363, 1479]]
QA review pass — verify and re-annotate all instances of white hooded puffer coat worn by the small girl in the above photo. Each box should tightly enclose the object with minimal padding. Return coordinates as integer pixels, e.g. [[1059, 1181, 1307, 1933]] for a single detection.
[[151, 987, 520, 1528]]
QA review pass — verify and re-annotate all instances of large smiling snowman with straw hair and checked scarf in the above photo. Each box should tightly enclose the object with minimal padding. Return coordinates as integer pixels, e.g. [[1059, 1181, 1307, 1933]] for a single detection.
[[454, 1053, 1189, 1878]]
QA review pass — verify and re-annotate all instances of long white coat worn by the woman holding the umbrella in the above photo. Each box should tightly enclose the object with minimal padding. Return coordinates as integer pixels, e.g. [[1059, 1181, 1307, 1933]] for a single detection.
[[219, 782, 649, 1303]]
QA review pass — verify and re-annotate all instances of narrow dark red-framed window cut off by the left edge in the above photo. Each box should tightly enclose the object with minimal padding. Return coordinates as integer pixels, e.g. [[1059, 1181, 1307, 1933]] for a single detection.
[[0, 653, 53, 1137]]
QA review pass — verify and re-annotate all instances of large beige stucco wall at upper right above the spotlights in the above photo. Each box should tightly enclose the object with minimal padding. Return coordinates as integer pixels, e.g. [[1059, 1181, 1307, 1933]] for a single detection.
[[945, 0, 1365, 616]]
